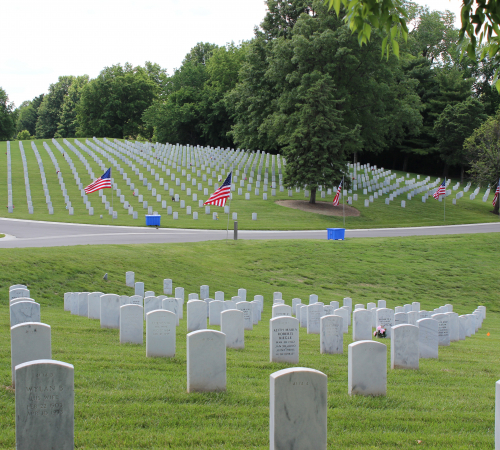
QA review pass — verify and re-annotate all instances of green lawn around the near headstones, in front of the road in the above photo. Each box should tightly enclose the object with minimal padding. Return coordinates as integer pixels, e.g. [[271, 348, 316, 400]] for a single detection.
[[0, 234, 500, 449]]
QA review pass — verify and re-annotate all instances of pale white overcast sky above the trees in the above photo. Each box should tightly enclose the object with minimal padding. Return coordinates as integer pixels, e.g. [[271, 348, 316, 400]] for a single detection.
[[0, 0, 462, 106]]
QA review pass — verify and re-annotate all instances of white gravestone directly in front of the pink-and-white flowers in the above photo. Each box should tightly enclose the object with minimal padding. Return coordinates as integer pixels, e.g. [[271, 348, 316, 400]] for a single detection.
[[347, 341, 387, 396]]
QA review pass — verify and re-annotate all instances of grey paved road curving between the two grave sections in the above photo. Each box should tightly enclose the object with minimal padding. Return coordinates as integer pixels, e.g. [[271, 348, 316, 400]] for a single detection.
[[0, 218, 500, 248]]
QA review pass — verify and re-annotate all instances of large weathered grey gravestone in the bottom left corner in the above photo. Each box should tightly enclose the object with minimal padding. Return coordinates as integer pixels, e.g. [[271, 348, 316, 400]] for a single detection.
[[15, 359, 75, 450]]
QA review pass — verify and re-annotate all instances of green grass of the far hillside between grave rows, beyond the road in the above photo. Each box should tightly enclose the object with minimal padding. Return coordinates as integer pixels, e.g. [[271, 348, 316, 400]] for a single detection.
[[0, 139, 499, 230]]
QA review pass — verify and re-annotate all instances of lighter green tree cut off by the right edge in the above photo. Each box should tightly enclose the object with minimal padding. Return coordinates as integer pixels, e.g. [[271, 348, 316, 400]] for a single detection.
[[464, 112, 500, 215]]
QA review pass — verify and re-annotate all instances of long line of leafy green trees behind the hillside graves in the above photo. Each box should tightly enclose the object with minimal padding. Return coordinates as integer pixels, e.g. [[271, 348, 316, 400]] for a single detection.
[[0, 0, 500, 185]]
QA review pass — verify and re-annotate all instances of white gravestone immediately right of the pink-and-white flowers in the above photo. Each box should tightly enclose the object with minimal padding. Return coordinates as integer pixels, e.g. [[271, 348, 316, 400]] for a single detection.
[[391, 324, 420, 369]]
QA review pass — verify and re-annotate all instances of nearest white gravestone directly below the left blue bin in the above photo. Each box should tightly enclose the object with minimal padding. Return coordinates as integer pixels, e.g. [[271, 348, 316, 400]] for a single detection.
[[146, 309, 177, 358]]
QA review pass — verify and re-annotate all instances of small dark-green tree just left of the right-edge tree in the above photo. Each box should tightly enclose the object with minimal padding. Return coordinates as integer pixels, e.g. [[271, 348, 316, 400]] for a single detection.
[[434, 98, 488, 183]]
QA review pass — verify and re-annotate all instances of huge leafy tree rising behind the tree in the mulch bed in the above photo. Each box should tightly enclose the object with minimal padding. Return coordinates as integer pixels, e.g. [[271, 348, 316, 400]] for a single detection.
[[227, 1, 422, 163]]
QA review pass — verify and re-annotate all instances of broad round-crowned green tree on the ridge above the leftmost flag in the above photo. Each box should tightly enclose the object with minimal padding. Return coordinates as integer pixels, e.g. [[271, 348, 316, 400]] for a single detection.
[[76, 63, 157, 139]]
